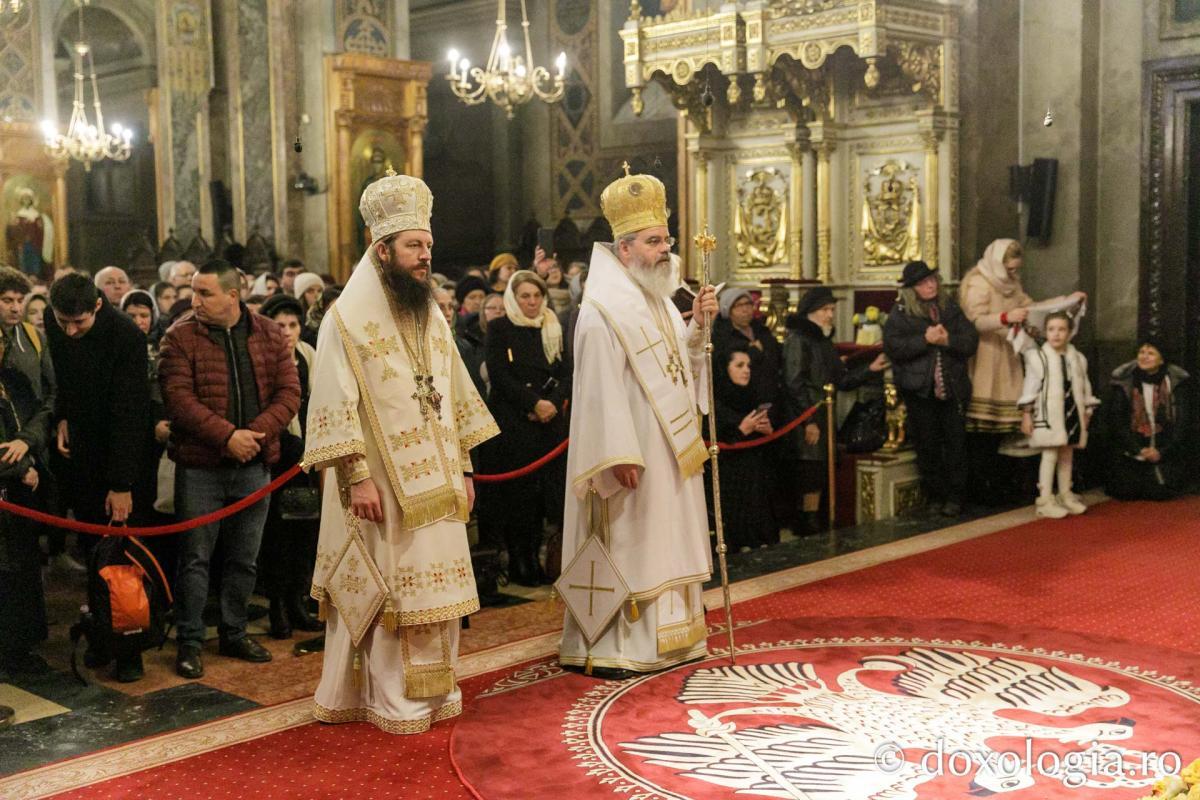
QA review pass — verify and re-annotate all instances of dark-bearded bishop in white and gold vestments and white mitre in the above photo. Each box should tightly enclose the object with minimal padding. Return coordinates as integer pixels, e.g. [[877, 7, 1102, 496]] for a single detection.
[[304, 170, 499, 733]]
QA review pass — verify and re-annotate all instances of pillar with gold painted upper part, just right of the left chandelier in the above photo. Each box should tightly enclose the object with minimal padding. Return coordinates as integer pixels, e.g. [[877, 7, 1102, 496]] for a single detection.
[[155, 0, 215, 245]]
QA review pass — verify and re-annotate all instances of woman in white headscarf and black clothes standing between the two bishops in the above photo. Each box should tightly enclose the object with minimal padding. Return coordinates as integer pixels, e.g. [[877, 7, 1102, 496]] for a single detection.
[[480, 270, 571, 585]]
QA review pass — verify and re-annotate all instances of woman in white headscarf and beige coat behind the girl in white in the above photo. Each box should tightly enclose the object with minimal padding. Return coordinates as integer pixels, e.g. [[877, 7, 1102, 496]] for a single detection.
[[959, 239, 1087, 497]]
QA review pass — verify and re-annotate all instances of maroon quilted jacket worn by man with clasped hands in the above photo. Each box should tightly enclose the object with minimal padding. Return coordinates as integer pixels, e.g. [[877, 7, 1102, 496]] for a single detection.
[[158, 306, 300, 468]]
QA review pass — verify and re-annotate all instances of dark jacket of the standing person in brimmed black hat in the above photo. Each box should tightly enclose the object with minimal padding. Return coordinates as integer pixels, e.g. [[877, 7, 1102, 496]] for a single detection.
[[883, 299, 979, 403]]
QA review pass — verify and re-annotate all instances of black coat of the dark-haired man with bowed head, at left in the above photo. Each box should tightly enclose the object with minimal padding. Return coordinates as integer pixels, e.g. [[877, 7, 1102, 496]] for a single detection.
[[46, 297, 151, 492]]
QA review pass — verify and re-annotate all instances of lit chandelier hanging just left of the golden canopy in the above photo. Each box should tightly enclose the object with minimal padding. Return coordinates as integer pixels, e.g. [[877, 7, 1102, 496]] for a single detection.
[[446, 0, 566, 120]]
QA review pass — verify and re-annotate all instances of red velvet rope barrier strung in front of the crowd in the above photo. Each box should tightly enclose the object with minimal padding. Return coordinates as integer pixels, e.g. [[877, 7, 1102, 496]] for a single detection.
[[0, 403, 822, 536]]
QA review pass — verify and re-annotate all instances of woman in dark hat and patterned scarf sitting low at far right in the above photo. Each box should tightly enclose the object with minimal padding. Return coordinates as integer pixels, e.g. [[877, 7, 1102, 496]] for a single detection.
[[1105, 338, 1193, 500]]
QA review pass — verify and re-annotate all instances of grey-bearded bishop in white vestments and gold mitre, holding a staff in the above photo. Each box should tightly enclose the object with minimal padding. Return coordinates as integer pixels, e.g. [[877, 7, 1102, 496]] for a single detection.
[[559, 167, 718, 678]]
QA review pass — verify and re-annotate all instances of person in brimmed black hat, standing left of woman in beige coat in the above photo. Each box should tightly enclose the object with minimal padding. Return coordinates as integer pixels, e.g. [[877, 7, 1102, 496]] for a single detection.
[[883, 261, 979, 517]]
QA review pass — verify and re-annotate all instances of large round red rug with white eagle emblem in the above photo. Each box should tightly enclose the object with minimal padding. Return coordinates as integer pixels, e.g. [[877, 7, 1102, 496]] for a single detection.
[[450, 618, 1200, 800]]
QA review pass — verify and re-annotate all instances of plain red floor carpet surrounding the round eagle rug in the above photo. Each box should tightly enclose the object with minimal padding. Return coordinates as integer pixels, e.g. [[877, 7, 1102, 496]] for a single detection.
[[42, 498, 1200, 800]]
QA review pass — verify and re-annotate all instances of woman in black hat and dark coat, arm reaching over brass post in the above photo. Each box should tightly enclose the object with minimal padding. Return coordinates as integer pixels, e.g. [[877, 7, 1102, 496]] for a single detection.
[[784, 287, 888, 534]]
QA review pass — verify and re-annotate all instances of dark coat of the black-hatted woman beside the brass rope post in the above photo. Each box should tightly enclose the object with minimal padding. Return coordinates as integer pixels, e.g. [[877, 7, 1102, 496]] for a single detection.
[[782, 314, 871, 462]]
